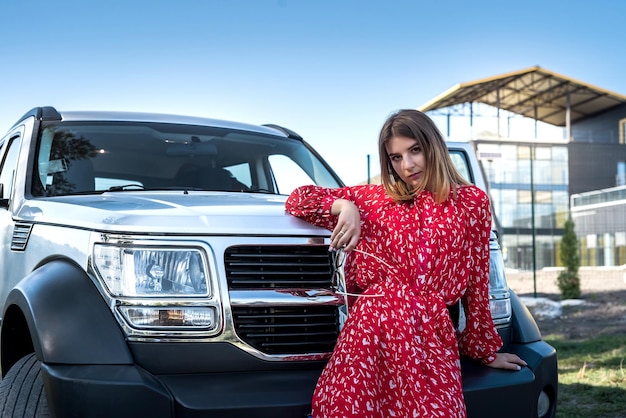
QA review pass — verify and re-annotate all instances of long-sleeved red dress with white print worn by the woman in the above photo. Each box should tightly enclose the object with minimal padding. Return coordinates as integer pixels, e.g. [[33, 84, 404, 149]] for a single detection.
[[286, 185, 502, 418]]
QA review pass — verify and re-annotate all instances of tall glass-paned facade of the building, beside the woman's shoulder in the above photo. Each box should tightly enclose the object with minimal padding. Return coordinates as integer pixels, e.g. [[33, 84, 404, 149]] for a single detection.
[[474, 141, 569, 270]]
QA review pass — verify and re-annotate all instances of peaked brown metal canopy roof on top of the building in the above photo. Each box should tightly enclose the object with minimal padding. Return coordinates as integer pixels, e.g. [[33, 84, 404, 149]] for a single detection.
[[418, 66, 626, 126]]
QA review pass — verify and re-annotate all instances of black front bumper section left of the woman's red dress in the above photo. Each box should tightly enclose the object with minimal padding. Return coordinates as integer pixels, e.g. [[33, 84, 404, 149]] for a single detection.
[[42, 342, 324, 418]]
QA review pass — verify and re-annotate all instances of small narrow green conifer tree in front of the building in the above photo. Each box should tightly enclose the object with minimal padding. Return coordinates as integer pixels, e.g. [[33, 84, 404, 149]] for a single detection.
[[556, 216, 580, 299]]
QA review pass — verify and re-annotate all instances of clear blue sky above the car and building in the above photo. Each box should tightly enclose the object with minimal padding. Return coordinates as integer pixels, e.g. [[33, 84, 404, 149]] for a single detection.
[[0, 0, 626, 184]]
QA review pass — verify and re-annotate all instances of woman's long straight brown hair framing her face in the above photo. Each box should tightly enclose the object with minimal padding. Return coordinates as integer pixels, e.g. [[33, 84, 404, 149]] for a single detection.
[[378, 109, 469, 203]]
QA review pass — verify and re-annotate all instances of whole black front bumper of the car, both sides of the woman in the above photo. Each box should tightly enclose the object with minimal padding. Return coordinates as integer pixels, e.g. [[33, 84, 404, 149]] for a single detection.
[[42, 341, 557, 418]]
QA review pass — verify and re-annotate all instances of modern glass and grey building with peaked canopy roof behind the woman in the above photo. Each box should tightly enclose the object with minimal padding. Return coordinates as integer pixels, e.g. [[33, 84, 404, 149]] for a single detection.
[[418, 67, 626, 270]]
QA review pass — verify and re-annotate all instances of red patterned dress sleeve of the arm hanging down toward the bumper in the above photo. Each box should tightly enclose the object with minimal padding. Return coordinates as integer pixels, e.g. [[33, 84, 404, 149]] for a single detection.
[[459, 188, 502, 362]]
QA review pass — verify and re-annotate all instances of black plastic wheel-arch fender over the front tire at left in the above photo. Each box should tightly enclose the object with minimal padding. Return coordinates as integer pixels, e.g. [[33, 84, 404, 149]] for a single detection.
[[2, 259, 133, 371]]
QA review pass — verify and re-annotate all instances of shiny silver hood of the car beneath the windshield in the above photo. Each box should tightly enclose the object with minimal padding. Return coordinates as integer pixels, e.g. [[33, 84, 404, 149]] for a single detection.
[[17, 191, 329, 236]]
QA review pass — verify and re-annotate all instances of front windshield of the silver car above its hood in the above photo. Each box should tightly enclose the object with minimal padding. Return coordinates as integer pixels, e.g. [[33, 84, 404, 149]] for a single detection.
[[32, 122, 341, 196]]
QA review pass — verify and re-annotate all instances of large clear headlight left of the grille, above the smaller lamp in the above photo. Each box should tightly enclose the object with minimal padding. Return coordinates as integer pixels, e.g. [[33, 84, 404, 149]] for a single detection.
[[94, 244, 211, 297]]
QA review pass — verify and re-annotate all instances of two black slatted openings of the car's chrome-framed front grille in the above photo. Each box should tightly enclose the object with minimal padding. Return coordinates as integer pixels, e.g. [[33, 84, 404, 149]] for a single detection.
[[224, 245, 339, 355]]
